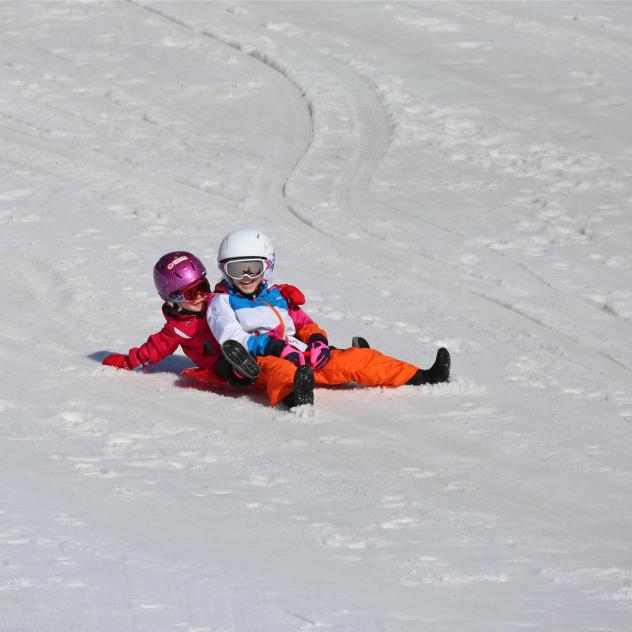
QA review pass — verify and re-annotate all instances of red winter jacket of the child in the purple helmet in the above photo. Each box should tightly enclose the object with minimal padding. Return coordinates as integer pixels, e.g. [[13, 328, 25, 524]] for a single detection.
[[128, 297, 222, 371]]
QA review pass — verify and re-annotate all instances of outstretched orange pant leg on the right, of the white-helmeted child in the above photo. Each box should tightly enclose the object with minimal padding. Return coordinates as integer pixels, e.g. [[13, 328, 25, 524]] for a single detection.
[[314, 347, 418, 386]]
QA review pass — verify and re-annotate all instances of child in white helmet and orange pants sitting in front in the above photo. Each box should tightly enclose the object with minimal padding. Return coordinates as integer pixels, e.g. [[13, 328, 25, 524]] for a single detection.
[[207, 228, 450, 407]]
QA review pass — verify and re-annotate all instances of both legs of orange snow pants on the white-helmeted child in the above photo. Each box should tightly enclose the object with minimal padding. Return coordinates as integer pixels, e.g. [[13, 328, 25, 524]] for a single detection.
[[255, 347, 418, 406]]
